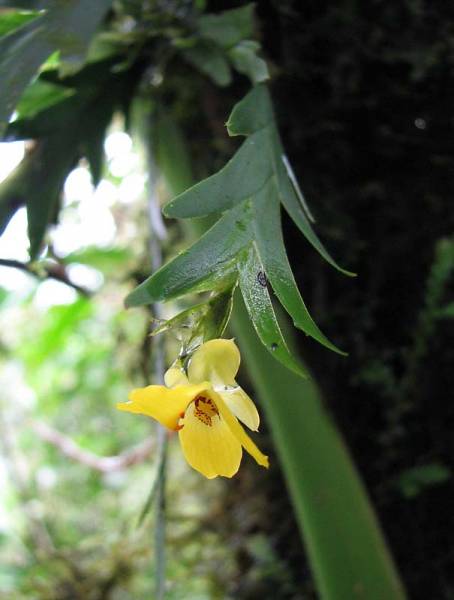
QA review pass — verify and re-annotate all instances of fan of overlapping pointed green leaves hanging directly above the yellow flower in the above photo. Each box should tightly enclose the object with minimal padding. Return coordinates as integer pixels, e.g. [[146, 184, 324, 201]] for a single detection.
[[126, 85, 349, 372]]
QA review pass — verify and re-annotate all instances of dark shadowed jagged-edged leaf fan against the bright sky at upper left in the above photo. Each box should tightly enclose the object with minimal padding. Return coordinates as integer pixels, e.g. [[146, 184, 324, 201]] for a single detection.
[[0, 61, 131, 259]]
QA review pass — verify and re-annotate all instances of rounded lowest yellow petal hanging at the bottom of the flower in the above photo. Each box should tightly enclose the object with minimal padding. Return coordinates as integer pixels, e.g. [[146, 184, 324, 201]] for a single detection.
[[178, 396, 242, 479]]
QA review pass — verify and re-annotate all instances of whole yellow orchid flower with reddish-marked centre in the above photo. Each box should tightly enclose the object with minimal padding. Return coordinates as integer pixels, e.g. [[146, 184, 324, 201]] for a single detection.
[[117, 339, 268, 479]]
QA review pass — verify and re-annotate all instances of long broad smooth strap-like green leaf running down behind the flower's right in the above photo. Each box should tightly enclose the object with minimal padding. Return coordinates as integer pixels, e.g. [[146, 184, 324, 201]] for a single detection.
[[231, 299, 407, 600]]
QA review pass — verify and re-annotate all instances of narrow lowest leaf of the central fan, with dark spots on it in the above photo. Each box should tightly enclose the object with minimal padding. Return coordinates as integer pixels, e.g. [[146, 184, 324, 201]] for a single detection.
[[238, 244, 307, 377]]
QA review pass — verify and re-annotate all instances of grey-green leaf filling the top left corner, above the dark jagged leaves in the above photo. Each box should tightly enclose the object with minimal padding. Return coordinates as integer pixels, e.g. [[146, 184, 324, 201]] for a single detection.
[[0, 0, 111, 135]]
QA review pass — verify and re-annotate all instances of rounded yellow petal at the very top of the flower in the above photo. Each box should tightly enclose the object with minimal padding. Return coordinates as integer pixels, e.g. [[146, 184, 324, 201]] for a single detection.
[[188, 339, 240, 385]]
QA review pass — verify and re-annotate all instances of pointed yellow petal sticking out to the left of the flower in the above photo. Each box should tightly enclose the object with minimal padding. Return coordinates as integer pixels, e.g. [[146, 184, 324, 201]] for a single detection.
[[117, 382, 210, 430]]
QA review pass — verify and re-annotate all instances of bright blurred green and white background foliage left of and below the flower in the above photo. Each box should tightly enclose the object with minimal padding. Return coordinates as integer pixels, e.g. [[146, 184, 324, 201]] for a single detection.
[[0, 129, 235, 599]]
